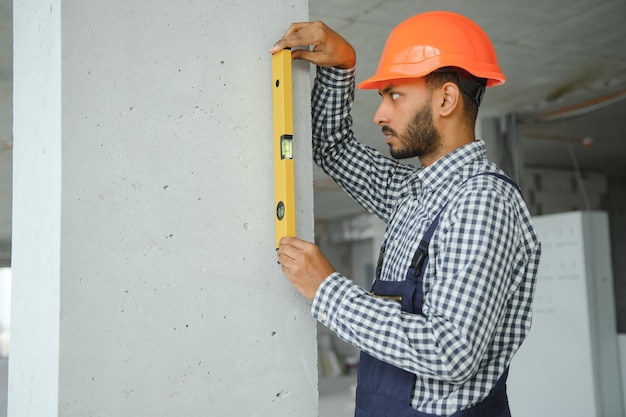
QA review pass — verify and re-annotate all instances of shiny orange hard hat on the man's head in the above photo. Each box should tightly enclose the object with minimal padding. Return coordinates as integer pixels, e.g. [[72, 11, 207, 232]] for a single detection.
[[359, 11, 506, 89]]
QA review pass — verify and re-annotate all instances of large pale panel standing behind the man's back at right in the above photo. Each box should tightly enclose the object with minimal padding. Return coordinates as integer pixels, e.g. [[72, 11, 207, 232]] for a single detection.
[[509, 212, 622, 417]]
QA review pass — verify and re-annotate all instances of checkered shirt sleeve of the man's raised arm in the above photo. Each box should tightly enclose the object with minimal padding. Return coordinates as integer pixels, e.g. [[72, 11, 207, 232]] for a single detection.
[[312, 67, 414, 221]]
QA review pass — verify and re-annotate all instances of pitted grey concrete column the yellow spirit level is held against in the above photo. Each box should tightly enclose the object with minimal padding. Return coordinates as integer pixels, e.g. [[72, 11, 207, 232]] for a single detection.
[[8, 0, 317, 417]]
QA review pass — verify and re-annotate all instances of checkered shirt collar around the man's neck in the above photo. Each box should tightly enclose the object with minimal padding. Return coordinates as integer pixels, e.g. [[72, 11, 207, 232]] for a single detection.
[[417, 140, 487, 191]]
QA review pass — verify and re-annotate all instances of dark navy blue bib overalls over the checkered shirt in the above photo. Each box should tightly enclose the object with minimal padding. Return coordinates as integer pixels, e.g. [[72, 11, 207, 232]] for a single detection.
[[355, 172, 521, 417]]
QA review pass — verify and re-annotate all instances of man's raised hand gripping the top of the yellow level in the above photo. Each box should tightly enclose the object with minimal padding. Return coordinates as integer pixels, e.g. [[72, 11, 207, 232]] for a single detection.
[[270, 21, 356, 69]]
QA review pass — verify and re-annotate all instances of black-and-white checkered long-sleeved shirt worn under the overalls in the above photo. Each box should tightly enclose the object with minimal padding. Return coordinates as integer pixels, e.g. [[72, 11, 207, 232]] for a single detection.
[[312, 68, 540, 415]]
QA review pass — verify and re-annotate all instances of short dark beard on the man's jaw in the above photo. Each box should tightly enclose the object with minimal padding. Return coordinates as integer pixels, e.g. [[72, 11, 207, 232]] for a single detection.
[[383, 101, 441, 159]]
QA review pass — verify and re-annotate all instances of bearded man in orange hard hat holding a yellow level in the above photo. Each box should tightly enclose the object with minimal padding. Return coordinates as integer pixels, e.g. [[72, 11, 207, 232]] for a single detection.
[[270, 12, 540, 417]]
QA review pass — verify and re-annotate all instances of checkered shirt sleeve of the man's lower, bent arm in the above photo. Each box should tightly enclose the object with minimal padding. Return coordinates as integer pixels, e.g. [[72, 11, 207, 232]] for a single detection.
[[312, 184, 532, 384]]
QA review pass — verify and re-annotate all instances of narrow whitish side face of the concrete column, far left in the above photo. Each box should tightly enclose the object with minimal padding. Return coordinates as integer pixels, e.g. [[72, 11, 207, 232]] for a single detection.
[[9, 1, 62, 417]]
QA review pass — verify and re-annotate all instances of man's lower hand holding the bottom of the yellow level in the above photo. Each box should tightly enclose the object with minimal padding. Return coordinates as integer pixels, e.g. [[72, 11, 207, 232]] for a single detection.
[[276, 237, 335, 300]]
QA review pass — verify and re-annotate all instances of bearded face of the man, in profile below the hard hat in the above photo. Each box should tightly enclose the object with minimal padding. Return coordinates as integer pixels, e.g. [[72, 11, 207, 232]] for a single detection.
[[374, 79, 441, 159]]
